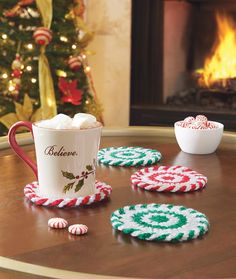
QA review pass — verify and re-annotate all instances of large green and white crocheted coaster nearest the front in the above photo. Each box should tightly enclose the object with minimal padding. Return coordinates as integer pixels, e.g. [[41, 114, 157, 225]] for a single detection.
[[111, 203, 209, 242]]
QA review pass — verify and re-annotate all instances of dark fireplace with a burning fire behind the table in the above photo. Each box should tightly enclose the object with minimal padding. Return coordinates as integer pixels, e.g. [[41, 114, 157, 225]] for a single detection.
[[130, 0, 236, 130]]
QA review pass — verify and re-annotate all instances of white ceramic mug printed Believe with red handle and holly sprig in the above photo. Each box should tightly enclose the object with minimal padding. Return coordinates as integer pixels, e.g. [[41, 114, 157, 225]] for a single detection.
[[8, 121, 102, 198]]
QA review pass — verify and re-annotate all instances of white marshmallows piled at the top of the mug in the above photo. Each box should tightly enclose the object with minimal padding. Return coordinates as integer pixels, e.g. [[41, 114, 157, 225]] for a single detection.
[[37, 113, 98, 129]]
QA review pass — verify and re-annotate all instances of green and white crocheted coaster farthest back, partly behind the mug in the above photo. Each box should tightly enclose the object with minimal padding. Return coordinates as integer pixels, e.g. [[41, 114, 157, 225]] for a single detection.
[[98, 146, 162, 167]]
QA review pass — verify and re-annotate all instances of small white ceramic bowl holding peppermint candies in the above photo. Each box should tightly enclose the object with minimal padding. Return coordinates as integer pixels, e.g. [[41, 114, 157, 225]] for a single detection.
[[175, 121, 224, 154]]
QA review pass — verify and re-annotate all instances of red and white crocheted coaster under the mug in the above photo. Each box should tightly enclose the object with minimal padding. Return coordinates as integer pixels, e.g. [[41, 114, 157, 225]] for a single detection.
[[24, 181, 112, 208]]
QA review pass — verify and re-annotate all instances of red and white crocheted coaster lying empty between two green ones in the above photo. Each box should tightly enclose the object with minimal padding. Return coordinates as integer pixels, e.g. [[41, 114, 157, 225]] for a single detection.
[[131, 166, 207, 192]]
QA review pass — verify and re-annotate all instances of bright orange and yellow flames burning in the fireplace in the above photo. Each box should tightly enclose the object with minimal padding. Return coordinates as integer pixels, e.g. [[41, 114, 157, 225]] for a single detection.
[[198, 12, 236, 87]]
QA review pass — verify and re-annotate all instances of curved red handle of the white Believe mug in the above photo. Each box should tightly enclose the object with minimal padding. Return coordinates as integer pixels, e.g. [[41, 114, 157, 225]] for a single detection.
[[8, 121, 38, 178]]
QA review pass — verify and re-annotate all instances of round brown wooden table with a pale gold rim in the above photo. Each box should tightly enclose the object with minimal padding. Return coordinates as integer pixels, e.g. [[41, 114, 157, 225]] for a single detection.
[[0, 127, 236, 279]]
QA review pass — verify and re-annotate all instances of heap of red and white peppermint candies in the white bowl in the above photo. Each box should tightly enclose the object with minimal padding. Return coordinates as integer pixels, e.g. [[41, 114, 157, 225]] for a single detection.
[[176, 114, 218, 130]]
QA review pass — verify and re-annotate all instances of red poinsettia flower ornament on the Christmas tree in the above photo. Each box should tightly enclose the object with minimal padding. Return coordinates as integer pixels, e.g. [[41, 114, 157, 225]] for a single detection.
[[58, 77, 83, 105]]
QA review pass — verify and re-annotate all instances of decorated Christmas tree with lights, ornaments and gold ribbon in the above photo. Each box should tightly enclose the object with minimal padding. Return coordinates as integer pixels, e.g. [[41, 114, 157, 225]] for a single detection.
[[0, 0, 102, 135]]
